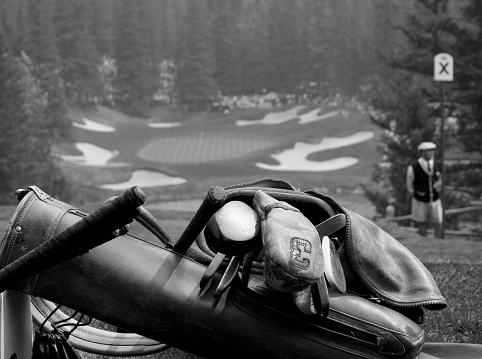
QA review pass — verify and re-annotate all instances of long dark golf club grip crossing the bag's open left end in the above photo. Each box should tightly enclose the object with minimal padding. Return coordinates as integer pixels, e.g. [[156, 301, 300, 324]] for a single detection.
[[0, 187, 146, 292]]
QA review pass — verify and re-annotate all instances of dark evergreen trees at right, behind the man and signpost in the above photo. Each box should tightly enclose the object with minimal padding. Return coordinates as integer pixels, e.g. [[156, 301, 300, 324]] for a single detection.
[[367, 0, 482, 219]]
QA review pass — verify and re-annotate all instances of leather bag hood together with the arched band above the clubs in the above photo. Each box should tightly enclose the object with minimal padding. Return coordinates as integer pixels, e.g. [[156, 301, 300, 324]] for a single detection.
[[219, 179, 447, 310]]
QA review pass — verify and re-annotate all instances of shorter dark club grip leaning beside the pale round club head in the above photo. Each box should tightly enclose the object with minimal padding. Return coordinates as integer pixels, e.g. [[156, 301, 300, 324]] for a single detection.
[[173, 186, 226, 254]]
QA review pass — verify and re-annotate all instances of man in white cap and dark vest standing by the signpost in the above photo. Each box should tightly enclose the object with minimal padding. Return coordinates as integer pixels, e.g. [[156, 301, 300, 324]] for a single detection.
[[407, 142, 443, 238]]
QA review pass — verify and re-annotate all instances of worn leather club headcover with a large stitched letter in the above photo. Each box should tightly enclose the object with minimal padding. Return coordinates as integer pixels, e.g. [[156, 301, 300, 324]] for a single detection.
[[253, 190, 324, 292]]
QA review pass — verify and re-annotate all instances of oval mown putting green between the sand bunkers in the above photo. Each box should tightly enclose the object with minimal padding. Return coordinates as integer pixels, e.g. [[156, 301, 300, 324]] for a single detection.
[[137, 132, 272, 164]]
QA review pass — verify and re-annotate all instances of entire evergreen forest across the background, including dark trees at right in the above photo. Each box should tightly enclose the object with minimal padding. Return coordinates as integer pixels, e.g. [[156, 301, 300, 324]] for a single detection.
[[0, 0, 482, 217]]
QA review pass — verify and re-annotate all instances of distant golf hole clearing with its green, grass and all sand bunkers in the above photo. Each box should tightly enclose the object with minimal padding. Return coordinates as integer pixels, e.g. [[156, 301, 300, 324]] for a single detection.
[[54, 103, 380, 205]]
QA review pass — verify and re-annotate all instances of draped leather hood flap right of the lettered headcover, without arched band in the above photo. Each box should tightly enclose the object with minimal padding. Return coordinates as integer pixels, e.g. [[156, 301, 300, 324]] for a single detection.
[[309, 192, 447, 310]]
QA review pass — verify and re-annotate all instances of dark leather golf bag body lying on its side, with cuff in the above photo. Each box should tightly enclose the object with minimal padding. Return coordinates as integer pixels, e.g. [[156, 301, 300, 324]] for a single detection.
[[0, 190, 430, 358]]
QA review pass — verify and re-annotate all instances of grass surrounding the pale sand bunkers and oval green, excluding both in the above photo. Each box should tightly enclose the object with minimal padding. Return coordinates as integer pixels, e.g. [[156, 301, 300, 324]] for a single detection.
[[59, 107, 380, 205]]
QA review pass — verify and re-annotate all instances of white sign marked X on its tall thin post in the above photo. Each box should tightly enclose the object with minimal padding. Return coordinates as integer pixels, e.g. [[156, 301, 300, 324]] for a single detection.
[[433, 53, 454, 238]]
